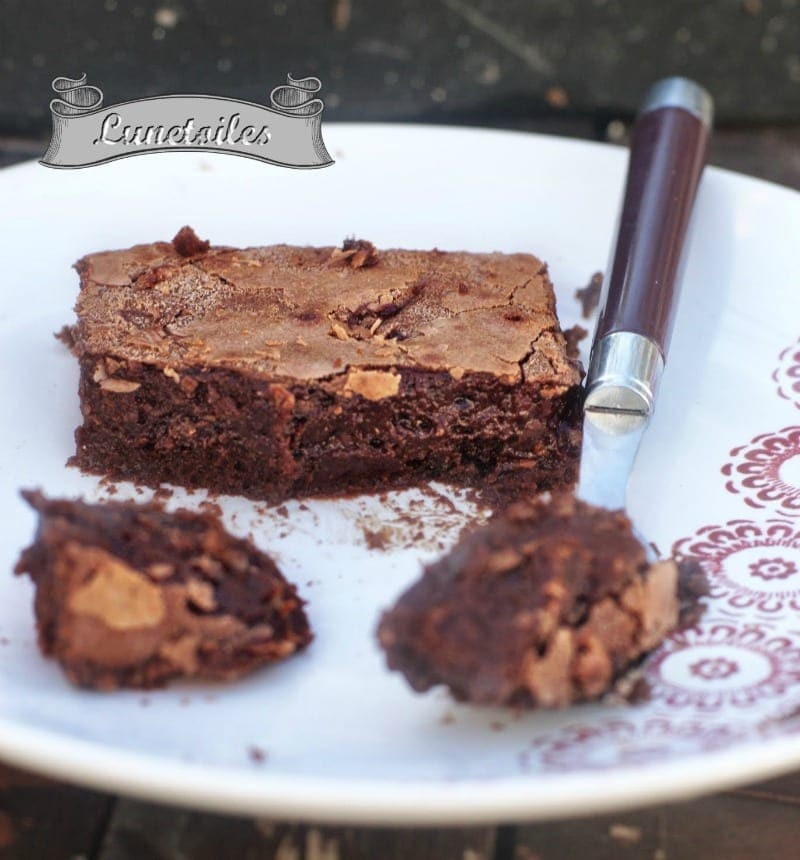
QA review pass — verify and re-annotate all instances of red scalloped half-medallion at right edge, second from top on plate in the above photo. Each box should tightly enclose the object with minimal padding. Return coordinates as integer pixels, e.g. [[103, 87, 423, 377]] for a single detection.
[[722, 427, 800, 516]]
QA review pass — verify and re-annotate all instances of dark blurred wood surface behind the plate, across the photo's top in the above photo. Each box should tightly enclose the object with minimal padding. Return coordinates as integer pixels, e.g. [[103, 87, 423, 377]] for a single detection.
[[0, 0, 800, 133]]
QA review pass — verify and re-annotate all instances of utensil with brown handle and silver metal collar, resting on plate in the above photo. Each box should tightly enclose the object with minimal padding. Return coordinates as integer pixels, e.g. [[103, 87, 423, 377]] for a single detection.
[[578, 78, 714, 510]]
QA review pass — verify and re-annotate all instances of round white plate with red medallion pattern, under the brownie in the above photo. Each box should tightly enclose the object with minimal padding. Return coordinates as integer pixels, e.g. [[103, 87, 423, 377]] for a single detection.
[[0, 125, 800, 823]]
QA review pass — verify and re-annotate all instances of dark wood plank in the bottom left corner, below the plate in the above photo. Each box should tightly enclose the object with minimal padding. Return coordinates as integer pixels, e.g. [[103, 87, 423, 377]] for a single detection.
[[0, 765, 114, 860]]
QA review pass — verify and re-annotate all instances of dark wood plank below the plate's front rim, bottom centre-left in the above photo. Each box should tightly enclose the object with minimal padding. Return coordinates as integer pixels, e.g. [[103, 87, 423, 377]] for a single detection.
[[98, 800, 495, 860]]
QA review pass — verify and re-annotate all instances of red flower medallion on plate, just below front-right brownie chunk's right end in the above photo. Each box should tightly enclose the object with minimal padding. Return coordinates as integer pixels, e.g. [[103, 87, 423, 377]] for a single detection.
[[647, 619, 800, 713]]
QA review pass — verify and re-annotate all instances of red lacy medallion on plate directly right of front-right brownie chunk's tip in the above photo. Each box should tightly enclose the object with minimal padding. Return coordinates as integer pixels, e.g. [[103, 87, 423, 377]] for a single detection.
[[672, 519, 800, 617]]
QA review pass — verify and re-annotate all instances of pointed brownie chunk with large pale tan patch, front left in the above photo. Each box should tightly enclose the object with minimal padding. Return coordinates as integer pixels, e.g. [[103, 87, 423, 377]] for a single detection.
[[15, 491, 311, 690]]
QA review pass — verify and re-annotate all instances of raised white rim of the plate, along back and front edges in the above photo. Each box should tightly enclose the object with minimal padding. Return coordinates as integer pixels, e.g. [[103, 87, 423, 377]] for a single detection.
[[0, 122, 800, 826]]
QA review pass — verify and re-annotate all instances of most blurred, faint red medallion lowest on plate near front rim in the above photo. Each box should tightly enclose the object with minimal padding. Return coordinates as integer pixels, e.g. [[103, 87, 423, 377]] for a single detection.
[[531, 716, 746, 772]]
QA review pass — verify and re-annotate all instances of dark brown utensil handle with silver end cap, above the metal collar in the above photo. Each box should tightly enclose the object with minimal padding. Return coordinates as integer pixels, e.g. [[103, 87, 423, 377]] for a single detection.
[[595, 78, 712, 359]]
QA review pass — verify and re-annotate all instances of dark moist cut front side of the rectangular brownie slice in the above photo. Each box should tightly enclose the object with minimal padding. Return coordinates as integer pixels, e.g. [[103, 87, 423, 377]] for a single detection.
[[76, 356, 580, 500]]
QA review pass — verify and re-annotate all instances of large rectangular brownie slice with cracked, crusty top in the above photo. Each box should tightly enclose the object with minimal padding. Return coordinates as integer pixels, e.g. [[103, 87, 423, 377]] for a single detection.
[[63, 227, 581, 502]]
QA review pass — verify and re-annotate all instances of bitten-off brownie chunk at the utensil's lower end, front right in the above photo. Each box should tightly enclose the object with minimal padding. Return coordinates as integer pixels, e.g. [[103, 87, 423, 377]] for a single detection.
[[378, 493, 707, 708]]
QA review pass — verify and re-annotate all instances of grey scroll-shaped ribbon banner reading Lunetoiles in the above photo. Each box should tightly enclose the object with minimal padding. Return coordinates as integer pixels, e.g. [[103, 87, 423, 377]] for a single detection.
[[40, 75, 333, 168]]
